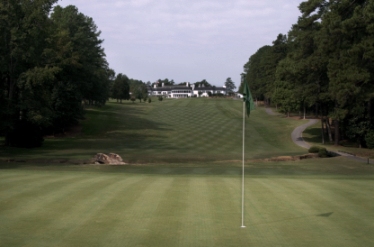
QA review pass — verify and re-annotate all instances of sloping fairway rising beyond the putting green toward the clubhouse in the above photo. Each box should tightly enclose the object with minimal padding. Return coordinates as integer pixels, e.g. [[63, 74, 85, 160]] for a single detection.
[[1, 98, 305, 163]]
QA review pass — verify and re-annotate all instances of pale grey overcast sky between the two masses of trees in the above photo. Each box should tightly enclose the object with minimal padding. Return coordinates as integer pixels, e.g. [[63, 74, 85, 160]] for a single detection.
[[58, 0, 302, 86]]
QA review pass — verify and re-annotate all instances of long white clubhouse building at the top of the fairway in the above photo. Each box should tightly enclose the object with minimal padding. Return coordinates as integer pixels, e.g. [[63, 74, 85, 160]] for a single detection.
[[148, 83, 227, 98]]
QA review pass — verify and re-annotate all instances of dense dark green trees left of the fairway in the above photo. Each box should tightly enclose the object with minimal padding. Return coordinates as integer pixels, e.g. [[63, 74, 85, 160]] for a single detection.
[[0, 0, 142, 147]]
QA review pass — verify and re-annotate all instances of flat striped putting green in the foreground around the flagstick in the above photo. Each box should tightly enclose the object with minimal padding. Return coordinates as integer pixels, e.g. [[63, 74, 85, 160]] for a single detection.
[[0, 158, 374, 246]]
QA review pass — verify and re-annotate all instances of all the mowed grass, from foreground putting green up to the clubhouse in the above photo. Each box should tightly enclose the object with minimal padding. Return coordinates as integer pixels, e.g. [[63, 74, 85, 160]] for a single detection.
[[0, 99, 374, 246]]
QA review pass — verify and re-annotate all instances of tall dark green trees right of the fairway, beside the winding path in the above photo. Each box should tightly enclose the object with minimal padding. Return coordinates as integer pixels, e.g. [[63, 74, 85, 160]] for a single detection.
[[239, 0, 374, 147]]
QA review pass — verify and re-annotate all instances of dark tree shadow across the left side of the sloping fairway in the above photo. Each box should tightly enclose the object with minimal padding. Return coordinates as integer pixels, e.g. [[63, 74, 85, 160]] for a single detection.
[[0, 104, 177, 160]]
